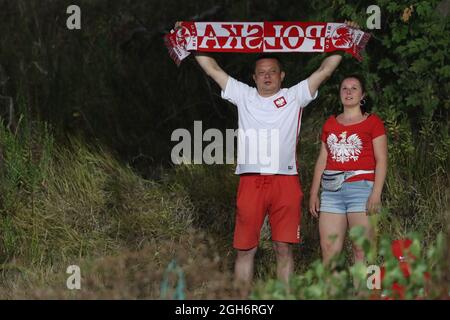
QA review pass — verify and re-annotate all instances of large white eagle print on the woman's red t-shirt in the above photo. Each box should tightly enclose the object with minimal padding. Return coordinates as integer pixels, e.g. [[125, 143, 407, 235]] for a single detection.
[[327, 131, 362, 163]]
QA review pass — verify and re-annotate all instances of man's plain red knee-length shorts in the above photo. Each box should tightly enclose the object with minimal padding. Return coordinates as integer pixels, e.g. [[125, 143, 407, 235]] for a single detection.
[[233, 174, 303, 250]]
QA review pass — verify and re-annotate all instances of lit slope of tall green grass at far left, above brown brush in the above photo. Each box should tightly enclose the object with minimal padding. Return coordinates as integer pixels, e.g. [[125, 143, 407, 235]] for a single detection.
[[0, 119, 209, 297]]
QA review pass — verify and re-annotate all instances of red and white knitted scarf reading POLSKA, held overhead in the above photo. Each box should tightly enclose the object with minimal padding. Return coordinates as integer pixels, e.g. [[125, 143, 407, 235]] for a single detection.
[[164, 21, 370, 65]]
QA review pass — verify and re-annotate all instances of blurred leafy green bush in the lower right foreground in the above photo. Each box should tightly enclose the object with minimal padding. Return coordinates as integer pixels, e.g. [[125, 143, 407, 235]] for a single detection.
[[251, 222, 450, 300]]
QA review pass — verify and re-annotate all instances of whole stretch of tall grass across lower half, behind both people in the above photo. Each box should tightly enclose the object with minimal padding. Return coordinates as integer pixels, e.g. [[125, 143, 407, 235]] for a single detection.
[[0, 118, 450, 299]]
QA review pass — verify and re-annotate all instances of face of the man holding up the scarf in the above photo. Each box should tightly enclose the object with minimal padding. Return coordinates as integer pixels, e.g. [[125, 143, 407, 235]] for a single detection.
[[253, 59, 284, 97]]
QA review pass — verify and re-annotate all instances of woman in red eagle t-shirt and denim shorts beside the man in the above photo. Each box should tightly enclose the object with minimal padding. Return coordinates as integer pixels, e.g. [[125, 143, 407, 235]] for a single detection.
[[309, 75, 387, 264]]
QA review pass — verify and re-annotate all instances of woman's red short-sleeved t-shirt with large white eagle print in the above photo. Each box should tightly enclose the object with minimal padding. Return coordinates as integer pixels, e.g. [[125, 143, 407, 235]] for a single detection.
[[322, 114, 386, 181]]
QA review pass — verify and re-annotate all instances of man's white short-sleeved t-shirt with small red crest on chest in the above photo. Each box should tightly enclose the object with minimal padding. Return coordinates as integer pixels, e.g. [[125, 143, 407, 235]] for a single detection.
[[222, 77, 317, 175]]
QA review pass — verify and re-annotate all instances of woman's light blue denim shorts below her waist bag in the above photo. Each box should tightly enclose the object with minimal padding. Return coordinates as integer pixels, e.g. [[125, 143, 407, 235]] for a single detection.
[[320, 180, 373, 214]]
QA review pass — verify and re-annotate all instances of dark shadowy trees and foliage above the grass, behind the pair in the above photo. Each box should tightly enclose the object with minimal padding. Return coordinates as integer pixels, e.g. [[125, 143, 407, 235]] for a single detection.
[[0, 0, 444, 175]]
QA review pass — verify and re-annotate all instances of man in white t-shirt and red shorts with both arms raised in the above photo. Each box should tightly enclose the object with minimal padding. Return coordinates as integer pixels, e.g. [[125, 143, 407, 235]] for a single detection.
[[175, 23, 357, 287]]
